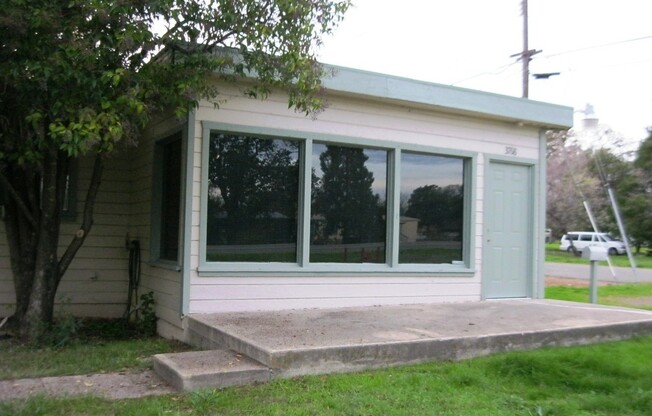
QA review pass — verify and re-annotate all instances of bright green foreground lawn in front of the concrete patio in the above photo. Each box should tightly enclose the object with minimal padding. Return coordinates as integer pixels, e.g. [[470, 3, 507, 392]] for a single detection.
[[0, 337, 652, 416]]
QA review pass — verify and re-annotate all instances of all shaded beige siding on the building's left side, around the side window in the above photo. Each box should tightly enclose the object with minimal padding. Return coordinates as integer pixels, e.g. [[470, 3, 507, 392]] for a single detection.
[[0, 117, 188, 338]]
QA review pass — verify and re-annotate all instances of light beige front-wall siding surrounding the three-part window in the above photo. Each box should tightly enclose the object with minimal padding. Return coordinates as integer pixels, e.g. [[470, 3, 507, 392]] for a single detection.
[[189, 86, 539, 313]]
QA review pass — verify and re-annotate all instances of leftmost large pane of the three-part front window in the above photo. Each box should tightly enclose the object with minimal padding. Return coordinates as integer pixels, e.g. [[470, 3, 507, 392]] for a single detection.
[[206, 133, 299, 262]]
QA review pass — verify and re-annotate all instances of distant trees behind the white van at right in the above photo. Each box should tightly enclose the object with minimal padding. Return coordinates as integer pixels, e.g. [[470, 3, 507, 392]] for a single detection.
[[546, 128, 652, 249]]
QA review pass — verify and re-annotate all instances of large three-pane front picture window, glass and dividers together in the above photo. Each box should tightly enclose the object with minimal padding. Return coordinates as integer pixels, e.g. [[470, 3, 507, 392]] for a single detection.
[[200, 128, 473, 273]]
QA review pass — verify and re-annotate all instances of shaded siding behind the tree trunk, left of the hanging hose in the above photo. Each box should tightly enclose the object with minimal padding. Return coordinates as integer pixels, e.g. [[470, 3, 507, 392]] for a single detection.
[[0, 152, 130, 317]]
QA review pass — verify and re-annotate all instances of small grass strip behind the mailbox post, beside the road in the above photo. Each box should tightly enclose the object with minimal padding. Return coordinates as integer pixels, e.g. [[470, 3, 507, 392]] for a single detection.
[[546, 283, 652, 310]]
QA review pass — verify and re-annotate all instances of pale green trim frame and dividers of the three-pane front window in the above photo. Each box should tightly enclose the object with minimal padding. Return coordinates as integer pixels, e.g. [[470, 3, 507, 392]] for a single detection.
[[198, 121, 477, 276]]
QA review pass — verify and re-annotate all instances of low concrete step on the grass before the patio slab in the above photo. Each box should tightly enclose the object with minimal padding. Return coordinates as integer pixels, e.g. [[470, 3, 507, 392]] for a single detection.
[[153, 350, 273, 391]]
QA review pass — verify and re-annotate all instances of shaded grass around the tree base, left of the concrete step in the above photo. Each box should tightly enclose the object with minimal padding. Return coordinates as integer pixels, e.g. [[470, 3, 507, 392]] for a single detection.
[[0, 320, 190, 380]]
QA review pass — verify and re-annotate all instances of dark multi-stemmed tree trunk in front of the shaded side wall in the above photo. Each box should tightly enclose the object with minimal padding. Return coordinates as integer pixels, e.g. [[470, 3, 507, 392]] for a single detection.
[[0, 148, 104, 343]]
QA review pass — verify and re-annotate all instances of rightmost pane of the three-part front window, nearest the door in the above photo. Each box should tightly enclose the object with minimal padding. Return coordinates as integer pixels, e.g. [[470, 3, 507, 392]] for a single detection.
[[399, 152, 464, 263]]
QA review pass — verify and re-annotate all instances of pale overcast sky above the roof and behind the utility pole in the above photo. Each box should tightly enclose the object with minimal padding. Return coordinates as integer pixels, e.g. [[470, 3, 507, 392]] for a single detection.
[[318, 0, 652, 150]]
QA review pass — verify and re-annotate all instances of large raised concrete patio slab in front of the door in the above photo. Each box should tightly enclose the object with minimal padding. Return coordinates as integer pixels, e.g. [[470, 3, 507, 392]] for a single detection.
[[189, 299, 652, 377]]
